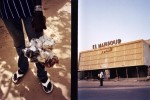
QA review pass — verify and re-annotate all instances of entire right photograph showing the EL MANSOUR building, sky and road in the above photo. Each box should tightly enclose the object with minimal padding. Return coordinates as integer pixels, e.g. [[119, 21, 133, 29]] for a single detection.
[[77, 0, 150, 100]]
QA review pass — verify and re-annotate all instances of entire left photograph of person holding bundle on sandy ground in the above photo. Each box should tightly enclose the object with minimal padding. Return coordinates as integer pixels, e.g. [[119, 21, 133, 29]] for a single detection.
[[0, 0, 71, 100]]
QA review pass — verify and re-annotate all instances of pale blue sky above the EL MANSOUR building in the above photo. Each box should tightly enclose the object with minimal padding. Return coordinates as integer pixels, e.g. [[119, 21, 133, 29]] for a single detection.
[[78, 0, 150, 52]]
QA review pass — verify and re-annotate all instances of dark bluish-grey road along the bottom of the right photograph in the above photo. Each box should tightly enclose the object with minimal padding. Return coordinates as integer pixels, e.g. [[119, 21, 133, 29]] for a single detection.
[[78, 87, 150, 100]]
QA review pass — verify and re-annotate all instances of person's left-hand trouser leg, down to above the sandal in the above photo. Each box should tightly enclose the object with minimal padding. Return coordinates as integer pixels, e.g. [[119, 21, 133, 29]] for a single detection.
[[3, 19, 29, 73]]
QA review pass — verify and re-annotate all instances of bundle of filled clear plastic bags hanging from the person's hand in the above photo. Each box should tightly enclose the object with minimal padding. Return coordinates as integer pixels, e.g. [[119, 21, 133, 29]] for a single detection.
[[23, 35, 59, 67]]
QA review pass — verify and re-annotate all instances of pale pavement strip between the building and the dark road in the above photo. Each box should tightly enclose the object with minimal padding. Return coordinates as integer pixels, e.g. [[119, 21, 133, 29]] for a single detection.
[[78, 78, 150, 88]]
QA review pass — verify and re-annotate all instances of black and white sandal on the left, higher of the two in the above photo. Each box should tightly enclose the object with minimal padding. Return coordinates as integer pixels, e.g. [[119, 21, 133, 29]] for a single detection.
[[12, 70, 24, 84]]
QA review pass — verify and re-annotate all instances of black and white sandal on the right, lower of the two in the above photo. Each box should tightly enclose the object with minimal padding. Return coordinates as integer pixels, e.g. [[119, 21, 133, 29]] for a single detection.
[[41, 79, 53, 93]]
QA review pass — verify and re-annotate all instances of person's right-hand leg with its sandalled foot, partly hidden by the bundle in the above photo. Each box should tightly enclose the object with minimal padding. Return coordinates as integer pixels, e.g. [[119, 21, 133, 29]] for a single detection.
[[23, 17, 53, 93]]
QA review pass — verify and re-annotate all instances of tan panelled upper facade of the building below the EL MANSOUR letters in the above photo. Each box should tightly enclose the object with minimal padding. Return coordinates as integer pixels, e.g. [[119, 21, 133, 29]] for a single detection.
[[78, 40, 150, 71]]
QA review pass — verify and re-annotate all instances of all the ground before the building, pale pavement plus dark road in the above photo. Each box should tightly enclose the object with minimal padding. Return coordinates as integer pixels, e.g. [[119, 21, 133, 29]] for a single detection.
[[78, 79, 150, 100]]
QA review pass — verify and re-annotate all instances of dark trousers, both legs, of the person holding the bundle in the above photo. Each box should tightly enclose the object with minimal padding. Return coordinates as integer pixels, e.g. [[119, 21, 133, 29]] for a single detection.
[[3, 17, 47, 80]]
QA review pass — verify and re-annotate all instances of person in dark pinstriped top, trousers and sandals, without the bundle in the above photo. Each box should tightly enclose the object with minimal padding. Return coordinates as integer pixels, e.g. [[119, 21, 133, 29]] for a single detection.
[[0, 0, 53, 93]]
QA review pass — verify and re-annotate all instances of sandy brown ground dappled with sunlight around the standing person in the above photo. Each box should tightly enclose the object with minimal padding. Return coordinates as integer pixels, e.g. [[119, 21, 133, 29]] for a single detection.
[[0, 0, 71, 100]]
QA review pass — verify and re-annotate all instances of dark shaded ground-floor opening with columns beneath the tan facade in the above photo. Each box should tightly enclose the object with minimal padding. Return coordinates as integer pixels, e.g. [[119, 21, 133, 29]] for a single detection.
[[79, 66, 148, 79]]
